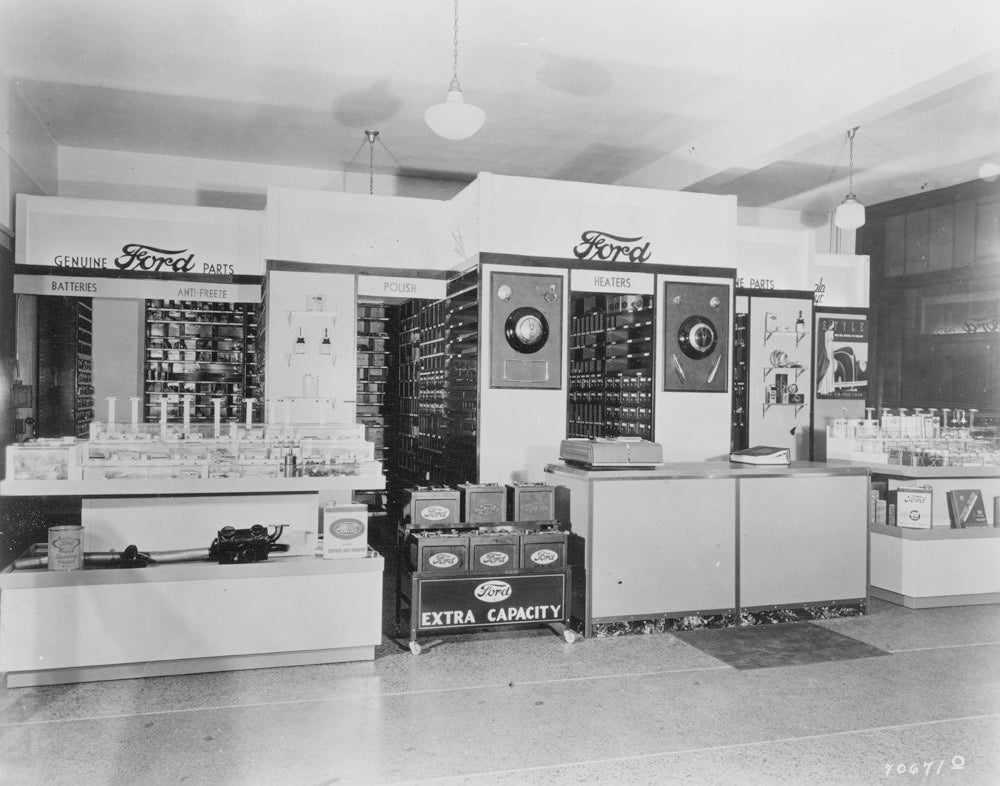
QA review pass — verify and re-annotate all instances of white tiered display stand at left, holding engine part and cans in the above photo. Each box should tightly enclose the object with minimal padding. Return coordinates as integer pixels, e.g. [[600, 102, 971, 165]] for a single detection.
[[0, 475, 385, 686]]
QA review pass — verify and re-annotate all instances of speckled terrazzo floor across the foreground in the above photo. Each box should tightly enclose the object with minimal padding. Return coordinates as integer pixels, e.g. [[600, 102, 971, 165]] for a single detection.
[[0, 556, 1000, 786]]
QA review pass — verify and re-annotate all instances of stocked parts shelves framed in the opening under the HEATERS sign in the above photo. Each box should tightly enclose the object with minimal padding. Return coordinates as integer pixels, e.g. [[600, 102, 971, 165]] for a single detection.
[[566, 293, 654, 440]]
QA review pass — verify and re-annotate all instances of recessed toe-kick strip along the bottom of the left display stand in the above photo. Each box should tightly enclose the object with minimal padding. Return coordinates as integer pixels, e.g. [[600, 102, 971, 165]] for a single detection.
[[6, 646, 375, 688]]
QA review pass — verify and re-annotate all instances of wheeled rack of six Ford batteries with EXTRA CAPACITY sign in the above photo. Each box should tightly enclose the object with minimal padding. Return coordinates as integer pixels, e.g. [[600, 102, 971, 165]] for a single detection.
[[395, 484, 576, 654]]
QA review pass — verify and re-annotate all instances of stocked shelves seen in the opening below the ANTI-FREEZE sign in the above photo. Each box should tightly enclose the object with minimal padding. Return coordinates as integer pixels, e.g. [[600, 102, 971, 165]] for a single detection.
[[143, 300, 258, 423]]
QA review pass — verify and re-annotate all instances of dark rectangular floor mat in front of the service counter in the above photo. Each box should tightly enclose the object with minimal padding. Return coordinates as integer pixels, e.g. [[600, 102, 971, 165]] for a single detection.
[[674, 622, 889, 669]]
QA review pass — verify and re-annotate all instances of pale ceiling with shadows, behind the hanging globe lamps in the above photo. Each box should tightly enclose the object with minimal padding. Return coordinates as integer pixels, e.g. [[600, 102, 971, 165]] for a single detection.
[[0, 0, 1000, 212]]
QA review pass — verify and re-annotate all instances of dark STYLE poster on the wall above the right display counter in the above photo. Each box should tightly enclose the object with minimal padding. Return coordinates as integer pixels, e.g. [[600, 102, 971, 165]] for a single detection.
[[816, 314, 868, 399]]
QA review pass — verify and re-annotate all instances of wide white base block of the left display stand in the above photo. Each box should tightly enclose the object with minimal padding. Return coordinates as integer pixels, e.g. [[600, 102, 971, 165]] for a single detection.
[[0, 557, 384, 684]]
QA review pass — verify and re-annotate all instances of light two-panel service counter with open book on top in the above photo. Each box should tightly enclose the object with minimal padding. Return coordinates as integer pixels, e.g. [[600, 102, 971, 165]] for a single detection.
[[545, 461, 869, 636]]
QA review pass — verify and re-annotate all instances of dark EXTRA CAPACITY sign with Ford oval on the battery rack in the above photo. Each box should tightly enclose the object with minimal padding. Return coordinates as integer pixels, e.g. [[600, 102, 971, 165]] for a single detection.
[[416, 573, 567, 631]]
